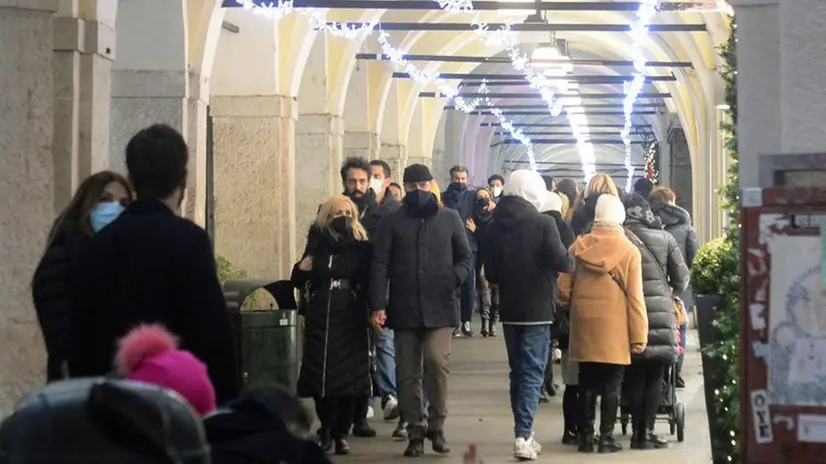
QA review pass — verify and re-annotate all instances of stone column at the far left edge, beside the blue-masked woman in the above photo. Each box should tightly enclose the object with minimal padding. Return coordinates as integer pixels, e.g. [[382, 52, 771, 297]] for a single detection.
[[0, 0, 57, 415]]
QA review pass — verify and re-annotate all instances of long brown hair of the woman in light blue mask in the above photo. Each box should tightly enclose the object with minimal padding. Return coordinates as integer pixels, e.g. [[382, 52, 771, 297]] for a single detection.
[[46, 171, 133, 250]]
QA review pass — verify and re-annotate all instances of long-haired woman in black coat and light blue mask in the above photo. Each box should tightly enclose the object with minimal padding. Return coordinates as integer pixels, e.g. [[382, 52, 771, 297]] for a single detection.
[[32, 171, 132, 382]]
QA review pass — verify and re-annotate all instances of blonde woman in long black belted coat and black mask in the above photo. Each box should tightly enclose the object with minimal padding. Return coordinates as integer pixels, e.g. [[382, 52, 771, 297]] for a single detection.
[[291, 195, 371, 454]]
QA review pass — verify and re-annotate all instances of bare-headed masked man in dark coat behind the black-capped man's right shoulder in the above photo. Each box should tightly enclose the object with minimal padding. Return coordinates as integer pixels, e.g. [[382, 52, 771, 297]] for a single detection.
[[442, 166, 478, 337]]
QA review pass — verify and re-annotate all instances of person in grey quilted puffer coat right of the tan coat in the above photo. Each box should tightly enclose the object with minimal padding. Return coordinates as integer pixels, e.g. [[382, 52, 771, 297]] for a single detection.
[[623, 194, 689, 449]]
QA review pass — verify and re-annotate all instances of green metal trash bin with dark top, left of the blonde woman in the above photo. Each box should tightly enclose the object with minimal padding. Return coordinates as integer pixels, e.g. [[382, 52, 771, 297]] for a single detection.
[[224, 280, 302, 393]]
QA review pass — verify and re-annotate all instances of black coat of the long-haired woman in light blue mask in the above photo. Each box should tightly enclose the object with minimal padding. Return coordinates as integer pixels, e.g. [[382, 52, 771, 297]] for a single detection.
[[32, 227, 92, 382]]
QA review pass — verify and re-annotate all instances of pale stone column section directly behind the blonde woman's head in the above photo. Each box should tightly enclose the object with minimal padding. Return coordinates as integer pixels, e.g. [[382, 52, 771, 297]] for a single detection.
[[295, 114, 344, 254]]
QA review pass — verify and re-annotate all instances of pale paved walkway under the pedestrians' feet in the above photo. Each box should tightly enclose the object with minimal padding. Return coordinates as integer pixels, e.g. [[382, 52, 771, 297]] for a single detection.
[[334, 332, 710, 464]]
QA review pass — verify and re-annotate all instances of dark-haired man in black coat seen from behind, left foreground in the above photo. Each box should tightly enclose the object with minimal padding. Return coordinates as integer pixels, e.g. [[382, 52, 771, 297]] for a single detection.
[[69, 125, 240, 404]]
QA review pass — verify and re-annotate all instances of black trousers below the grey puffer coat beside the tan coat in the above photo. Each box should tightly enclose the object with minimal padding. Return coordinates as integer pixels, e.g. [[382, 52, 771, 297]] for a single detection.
[[625, 362, 668, 433]]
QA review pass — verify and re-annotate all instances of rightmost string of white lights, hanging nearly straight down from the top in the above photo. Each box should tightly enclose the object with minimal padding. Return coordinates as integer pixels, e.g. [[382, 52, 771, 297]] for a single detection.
[[620, 0, 660, 192]]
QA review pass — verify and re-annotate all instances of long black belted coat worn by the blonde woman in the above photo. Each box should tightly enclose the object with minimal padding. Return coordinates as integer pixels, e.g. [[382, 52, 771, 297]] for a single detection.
[[291, 226, 371, 397]]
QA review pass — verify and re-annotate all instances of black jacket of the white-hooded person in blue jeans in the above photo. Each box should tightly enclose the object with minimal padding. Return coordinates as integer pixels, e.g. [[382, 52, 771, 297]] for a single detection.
[[482, 186, 572, 325]]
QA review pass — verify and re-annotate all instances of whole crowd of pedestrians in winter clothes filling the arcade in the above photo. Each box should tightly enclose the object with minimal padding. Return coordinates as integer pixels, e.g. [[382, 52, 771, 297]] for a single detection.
[[20, 121, 697, 463]]
